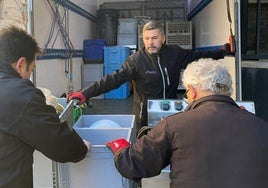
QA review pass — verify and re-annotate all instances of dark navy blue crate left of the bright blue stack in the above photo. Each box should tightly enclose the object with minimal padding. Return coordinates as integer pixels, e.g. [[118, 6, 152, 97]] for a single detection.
[[84, 39, 106, 60]]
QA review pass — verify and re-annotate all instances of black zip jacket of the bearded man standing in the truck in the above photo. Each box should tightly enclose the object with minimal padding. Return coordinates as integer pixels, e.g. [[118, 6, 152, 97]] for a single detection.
[[82, 45, 225, 125]]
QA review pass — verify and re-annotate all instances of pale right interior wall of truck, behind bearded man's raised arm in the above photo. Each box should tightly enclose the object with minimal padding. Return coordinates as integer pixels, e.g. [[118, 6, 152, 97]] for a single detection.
[[192, 0, 237, 100]]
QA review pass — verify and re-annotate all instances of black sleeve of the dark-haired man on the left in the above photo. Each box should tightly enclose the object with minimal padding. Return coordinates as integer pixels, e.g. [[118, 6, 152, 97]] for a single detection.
[[18, 93, 87, 162]]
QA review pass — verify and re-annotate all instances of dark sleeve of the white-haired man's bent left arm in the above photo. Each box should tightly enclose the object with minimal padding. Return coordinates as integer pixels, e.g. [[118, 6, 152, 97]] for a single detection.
[[115, 120, 171, 180]]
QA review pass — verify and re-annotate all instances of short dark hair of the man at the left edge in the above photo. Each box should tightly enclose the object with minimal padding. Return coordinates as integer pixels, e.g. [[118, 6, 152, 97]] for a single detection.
[[0, 26, 41, 66]]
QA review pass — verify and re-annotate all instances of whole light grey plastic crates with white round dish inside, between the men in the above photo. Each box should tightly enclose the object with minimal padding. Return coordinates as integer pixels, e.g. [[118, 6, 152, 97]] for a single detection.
[[56, 114, 136, 188]]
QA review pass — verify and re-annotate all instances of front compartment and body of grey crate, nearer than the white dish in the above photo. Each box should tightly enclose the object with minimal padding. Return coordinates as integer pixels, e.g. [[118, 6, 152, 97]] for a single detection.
[[58, 127, 135, 188]]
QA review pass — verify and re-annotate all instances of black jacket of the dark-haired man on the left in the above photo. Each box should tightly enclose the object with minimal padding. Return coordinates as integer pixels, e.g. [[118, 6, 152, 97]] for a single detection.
[[0, 65, 87, 188]]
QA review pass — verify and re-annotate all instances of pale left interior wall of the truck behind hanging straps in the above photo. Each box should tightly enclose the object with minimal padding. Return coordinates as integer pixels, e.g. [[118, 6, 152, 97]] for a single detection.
[[32, 0, 97, 97]]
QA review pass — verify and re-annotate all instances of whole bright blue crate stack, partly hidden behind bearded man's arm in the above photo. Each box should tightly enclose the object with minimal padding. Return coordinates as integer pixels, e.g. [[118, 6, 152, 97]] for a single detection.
[[104, 46, 130, 99]]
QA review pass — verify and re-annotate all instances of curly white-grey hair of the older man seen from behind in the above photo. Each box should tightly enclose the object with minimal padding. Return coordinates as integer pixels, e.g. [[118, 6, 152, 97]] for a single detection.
[[182, 58, 233, 96]]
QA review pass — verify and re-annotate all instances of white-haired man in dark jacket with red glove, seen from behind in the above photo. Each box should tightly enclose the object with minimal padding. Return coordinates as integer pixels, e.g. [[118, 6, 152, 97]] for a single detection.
[[107, 59, 268, 188]]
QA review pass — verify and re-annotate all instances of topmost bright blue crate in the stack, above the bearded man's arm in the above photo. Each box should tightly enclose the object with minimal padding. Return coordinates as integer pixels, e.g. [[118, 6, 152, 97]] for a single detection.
[[104, 46, 130, 65]]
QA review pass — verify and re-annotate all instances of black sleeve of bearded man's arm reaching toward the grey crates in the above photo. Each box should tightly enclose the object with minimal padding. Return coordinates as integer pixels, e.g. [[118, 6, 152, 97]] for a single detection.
[[82, 59, 136, 99]]
